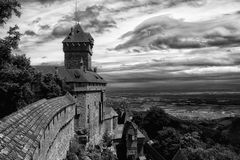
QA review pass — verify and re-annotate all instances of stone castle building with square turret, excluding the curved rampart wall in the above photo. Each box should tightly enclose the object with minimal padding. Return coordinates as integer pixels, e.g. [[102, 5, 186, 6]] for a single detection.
[[37, 24, 118, 143]]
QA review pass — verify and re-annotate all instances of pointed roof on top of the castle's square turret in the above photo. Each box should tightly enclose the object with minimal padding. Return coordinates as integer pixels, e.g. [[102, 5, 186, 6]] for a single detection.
[[63, 23, 94, 43]]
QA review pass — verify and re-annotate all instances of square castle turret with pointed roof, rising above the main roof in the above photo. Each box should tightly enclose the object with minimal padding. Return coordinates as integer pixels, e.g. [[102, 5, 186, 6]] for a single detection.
[[62, 24, 94, 70]]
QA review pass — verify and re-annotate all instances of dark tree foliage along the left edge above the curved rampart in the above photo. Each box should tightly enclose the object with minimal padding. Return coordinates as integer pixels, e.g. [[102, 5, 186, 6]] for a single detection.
[[0, 0, 64, 118]]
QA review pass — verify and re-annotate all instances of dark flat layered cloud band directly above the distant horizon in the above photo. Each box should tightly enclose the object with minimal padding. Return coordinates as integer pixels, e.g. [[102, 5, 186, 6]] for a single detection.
[[102, 62, 240, 92]]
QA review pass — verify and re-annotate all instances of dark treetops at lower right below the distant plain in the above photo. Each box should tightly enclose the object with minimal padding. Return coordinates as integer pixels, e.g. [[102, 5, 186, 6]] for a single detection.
[[134, 107, 240, 160]]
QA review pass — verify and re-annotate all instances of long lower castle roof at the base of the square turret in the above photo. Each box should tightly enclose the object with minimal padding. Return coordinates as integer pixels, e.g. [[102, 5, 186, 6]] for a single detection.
[[35, 66, 107, 84]]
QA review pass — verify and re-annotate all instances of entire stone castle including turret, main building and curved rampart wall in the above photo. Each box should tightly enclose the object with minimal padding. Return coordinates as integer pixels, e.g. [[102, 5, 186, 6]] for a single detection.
[[0, 24, 118, 160]]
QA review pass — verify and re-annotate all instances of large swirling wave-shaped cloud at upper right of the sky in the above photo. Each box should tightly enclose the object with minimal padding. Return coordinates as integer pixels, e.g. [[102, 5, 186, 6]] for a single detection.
[[116, 15, 240, 49]]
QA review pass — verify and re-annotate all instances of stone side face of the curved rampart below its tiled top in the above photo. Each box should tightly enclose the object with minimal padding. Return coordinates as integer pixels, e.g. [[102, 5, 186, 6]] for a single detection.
[[33, 106, 75, 160]]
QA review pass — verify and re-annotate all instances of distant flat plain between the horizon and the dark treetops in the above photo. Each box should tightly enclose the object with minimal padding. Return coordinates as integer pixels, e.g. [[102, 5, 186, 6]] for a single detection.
[[108, 92, 240, 120]]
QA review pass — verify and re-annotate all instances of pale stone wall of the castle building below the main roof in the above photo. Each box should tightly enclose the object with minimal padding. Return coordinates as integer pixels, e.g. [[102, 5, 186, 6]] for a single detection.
[[74, 86, 106, 144]]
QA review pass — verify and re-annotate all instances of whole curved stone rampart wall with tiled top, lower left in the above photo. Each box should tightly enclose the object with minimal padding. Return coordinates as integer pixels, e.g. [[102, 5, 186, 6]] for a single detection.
[[0, 95, 75, 160]]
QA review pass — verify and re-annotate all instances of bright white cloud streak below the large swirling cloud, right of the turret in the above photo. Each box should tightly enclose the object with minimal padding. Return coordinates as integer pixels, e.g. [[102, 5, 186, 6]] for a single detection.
[[102, 49, 240, 75]]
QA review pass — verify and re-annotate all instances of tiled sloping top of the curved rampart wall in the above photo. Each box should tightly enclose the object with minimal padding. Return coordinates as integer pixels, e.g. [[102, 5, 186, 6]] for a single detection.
[[0, 93, 75, 160]]
